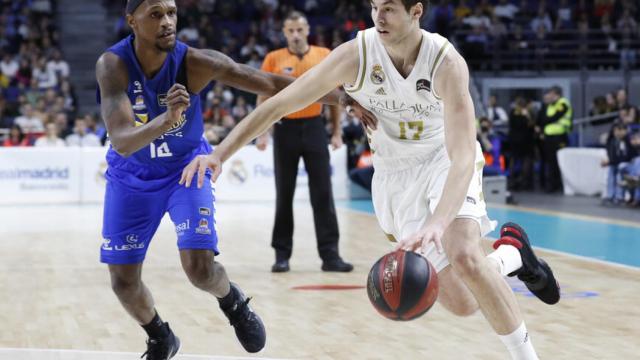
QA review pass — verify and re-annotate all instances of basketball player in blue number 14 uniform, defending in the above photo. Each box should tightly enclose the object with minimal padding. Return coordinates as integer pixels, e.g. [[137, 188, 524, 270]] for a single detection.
[[96, 0, 338, 360]]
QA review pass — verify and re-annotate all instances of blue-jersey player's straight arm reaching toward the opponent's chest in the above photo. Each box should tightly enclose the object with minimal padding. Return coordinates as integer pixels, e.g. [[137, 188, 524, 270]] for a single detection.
[[187, 48, 340, 105]]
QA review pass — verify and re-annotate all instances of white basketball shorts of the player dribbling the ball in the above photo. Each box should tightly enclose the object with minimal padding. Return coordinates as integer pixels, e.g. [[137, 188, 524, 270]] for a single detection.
[[372, 142, 497, 272]]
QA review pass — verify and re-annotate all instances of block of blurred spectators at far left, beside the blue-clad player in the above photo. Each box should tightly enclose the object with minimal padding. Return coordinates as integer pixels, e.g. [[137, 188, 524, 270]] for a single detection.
[[0, 0, 106, 147]]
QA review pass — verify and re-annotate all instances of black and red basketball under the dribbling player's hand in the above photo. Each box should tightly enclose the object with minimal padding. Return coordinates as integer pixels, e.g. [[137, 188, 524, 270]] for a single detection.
[[367, 250, 438, 321]]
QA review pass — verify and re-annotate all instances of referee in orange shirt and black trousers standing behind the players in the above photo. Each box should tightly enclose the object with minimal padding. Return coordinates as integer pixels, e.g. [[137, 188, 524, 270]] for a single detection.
[[256, 11, 353, 272]]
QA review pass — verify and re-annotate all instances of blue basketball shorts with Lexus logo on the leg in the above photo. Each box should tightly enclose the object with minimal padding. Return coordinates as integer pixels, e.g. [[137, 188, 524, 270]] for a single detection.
[[100, 175, 219, 264]]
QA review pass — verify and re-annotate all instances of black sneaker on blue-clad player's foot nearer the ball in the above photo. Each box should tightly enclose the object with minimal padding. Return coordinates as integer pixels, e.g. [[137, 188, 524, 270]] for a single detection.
[[220, 283, 267, 353]]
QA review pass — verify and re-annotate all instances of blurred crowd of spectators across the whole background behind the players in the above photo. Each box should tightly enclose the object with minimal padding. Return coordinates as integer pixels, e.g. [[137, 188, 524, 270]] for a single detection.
[[0, 0, 640, 205]]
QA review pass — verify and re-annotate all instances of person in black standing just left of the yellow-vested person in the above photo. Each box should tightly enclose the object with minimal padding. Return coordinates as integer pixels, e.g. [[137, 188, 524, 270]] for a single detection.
[[507, 96, 535, 190]]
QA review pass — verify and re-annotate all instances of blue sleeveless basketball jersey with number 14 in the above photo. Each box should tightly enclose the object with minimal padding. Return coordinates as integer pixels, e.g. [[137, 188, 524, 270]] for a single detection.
[[98, 35, 211, 191]]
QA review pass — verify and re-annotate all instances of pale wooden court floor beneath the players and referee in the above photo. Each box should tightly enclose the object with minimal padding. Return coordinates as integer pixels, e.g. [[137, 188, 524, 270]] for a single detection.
[[0, 202, 640, 360]]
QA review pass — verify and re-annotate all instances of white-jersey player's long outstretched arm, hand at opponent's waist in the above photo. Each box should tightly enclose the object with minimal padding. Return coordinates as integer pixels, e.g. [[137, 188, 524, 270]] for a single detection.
[[180, 41, 359, 187]]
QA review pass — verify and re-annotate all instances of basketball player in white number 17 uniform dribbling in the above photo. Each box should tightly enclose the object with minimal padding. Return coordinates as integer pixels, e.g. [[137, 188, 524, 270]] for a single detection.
[[181, 0, 560, 359]]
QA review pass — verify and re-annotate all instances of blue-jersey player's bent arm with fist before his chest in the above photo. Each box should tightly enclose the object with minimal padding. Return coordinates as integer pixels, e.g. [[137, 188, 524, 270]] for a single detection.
[[96, 53, 189, 156]]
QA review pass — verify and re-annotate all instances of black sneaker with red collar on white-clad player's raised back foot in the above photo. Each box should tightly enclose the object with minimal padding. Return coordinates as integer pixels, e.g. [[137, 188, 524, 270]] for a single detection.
[[493, 223, 560, 305]]
